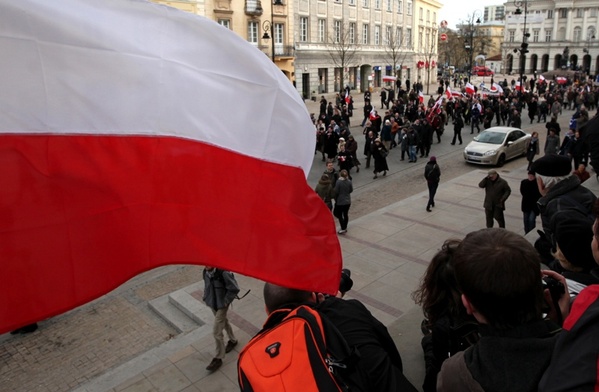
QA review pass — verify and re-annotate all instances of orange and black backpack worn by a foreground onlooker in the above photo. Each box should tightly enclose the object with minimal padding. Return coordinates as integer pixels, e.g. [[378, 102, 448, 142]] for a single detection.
[[237, 305, 362, 392]]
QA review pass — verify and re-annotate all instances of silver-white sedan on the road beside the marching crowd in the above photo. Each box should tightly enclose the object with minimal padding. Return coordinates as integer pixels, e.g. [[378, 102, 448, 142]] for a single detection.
[[464, 127, 531, 166]]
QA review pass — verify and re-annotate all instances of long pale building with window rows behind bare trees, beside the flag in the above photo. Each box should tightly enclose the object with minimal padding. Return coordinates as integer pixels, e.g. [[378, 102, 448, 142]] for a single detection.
[[293, 0, 441, 99]]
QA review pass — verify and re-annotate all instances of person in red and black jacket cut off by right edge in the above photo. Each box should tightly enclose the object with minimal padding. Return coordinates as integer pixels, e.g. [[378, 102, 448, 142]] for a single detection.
[[538, 201, 599, 392]]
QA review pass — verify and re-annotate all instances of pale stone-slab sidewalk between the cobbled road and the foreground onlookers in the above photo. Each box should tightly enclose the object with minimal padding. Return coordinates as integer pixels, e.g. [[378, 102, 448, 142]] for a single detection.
[[70, 162, 599, 392]]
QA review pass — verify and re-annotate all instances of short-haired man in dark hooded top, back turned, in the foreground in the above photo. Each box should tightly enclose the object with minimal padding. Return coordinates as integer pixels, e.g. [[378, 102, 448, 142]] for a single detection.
[[437, 228, 565, 392]]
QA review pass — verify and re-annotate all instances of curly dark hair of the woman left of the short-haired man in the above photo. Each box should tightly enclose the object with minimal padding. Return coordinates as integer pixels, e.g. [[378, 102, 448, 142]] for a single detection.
[[412, 240, 466, 324]]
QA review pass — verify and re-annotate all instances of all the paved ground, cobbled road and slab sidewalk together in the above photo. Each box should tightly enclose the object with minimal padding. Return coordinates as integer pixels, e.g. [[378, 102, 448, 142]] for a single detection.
[[0, 79, 584, 392]]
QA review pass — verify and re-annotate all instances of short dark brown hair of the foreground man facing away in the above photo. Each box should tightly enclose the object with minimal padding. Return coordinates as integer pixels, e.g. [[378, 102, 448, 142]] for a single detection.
[[453, 228, 544, 329]]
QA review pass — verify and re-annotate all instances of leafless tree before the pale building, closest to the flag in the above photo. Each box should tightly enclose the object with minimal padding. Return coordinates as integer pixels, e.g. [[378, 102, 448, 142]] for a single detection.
[[327, 22, 358, 92]]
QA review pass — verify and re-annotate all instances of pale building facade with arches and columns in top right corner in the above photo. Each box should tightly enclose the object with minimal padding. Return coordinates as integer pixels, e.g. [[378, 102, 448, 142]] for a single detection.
[[504, 0, 599, 75]]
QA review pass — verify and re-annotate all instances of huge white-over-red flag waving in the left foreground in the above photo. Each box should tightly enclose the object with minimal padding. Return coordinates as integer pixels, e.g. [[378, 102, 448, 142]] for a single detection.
[[0, 0, 341, 333]]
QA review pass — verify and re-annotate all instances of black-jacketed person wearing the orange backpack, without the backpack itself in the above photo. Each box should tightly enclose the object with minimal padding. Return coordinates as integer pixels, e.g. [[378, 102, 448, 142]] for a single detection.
[[263, 283, 416, 392]]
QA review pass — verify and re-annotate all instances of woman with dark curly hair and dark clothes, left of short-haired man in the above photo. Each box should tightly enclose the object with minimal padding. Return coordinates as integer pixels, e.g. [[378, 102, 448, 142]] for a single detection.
[[412, 240, 478, 392]]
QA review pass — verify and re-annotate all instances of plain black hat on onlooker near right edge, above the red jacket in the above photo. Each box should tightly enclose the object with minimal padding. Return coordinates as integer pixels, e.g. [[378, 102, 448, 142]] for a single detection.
[[551, 209, 597, 271]]
